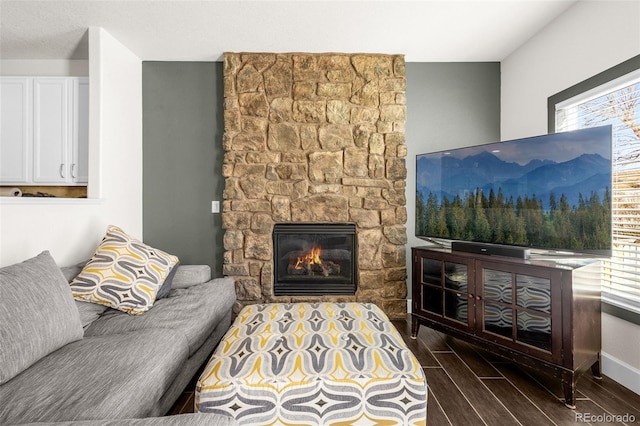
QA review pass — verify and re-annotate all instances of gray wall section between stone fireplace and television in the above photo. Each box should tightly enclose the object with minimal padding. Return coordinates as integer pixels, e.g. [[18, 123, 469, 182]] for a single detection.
[[405, 62, 500, 299]]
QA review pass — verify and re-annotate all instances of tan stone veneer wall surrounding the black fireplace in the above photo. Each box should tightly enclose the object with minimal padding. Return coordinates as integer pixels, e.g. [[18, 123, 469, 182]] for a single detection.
[[222, 53, 407, 318]]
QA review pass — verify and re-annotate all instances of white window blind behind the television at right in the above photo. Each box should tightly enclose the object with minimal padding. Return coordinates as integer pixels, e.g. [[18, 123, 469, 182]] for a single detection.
[[555, 70, 640, 313]]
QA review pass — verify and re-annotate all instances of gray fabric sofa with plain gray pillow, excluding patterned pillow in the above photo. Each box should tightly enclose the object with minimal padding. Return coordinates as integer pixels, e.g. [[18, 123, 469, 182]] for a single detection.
[[0, 252, 235, 425]]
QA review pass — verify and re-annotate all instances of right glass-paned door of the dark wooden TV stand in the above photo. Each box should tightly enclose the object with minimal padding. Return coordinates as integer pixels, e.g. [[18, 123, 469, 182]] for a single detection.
[[476, 261, 562, 360]]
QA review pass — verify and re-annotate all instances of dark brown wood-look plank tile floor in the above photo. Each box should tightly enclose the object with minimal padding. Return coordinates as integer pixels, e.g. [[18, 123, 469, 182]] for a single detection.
[[169, 320, 640, 426]]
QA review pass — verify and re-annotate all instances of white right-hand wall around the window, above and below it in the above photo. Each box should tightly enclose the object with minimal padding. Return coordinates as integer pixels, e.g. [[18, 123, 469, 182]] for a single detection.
[[501, 1, 640, 393]]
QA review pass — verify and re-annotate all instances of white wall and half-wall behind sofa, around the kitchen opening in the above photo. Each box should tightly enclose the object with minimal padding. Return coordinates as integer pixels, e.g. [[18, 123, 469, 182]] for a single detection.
[[0, 28, 142, 266]]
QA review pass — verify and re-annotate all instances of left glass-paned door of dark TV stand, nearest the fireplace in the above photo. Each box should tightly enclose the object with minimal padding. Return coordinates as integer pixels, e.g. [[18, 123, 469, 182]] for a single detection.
[[414, 253, 474, 328]]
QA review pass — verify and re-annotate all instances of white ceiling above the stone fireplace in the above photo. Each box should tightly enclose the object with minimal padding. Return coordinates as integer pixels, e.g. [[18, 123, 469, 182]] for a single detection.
[[0, 0, 576, 62]]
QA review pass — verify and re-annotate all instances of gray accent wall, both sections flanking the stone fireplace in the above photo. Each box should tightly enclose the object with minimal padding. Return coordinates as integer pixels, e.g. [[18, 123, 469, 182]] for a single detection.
[[142, 62, 500, 286]]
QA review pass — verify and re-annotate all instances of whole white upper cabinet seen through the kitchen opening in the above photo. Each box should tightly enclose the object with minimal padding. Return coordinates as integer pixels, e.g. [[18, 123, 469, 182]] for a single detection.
[[0, 77, 89, 185]]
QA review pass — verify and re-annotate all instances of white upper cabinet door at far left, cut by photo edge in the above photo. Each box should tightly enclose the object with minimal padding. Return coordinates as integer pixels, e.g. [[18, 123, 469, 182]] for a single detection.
[[0, 77, 31, 184]]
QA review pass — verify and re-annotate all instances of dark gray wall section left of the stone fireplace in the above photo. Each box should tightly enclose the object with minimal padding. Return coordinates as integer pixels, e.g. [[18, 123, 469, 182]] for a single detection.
[[142, 62, 224, 277]]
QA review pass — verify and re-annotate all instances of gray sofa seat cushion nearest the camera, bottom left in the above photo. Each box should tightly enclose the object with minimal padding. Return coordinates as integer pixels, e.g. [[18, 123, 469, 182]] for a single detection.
[[0, 330, 187, 424]]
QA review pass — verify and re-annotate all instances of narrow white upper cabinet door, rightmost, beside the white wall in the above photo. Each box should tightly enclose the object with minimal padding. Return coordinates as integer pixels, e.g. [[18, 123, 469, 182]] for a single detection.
[[69, 78, 89, 183]]
